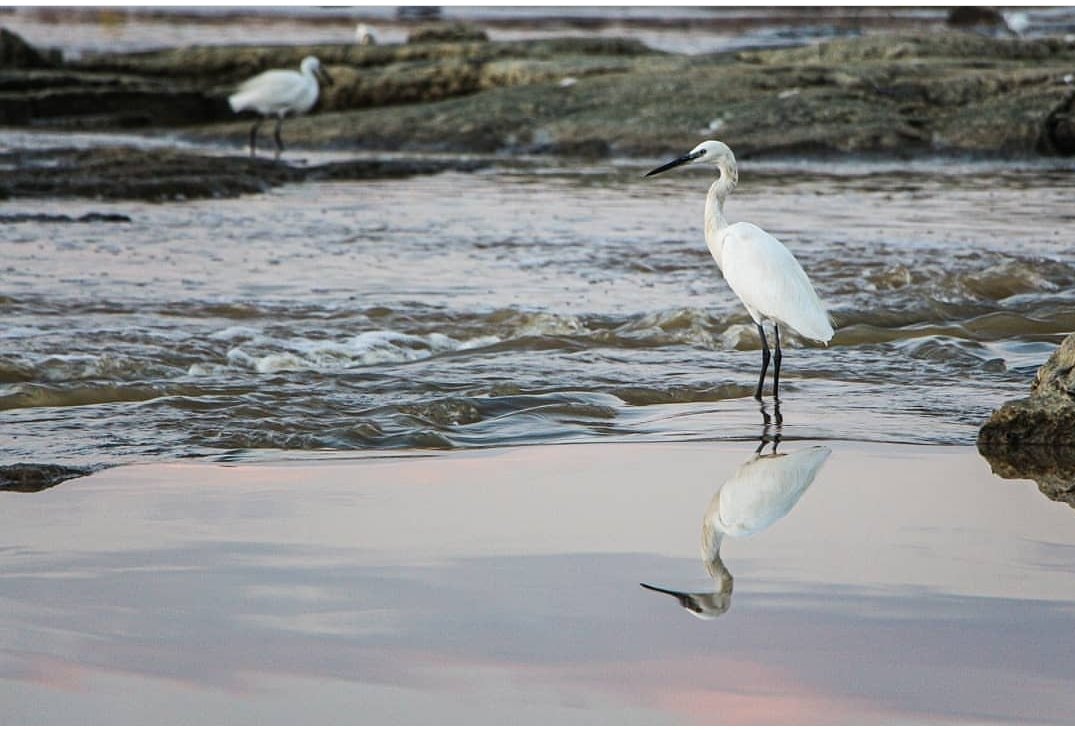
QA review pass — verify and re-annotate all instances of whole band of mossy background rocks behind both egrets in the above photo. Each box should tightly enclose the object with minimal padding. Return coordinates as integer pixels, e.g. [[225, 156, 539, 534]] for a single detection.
[[0, 24, 1075, 162]]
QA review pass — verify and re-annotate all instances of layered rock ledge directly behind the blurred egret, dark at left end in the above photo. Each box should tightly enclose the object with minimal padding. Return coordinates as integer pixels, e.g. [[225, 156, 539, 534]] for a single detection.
[[0, 34, 655, 129]]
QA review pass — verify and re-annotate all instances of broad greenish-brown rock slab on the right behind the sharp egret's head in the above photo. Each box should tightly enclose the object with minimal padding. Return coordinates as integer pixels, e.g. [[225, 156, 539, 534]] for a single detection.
[[189, 33, 1075, 157]]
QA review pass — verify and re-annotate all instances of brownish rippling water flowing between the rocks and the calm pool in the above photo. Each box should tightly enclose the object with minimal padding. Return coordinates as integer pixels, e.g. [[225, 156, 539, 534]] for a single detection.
[[0, 160, 1075, 462]]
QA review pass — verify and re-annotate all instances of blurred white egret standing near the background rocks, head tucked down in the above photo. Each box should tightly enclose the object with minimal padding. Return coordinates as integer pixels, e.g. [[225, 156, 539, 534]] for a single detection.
[[228, 56, 332, 159]]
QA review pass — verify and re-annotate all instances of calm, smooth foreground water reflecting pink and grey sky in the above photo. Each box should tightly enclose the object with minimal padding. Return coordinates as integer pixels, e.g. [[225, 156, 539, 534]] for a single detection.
[[0, 442, 1075, 725]]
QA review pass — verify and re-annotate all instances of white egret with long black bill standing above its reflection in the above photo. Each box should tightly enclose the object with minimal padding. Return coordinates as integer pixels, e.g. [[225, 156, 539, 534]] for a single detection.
[[646, 140, 833, 400]]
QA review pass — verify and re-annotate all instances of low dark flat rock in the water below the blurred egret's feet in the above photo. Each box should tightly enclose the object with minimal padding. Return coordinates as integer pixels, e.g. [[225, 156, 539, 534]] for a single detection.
[[0, 147, 492, 201]]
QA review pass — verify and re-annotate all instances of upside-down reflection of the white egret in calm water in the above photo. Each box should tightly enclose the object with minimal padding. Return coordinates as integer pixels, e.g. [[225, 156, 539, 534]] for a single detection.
[[640, 444, 832, 619]]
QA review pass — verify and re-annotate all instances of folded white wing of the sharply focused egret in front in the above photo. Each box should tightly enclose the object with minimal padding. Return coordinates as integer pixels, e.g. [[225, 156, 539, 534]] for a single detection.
[[721, 223, 832, 342]]
